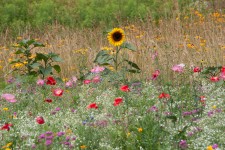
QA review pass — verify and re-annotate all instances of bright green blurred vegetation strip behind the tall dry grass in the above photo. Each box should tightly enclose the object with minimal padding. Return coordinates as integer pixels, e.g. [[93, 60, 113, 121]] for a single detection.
[[0, 0, 205, 31]]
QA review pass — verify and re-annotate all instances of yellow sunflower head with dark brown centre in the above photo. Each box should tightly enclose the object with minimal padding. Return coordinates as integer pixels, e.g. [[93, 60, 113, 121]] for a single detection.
[[107, 28, 125, 46]]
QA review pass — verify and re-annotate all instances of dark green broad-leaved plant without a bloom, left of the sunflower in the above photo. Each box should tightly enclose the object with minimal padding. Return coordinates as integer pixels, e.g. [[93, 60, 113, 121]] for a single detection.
[[10, 39, 62, 78]]
